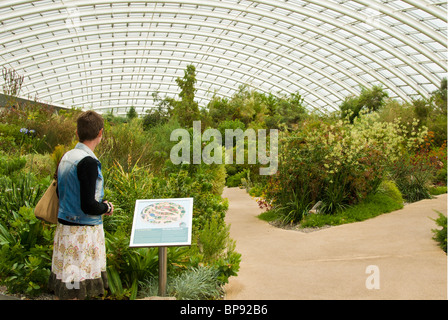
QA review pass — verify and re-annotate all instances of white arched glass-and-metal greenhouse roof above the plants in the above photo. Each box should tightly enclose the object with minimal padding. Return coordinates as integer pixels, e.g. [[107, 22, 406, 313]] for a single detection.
[[0, 0, 447, 114]]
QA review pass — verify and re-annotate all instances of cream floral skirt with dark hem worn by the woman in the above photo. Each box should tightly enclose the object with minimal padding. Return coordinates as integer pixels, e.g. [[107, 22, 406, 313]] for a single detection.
[[49, 223, 108, 299]]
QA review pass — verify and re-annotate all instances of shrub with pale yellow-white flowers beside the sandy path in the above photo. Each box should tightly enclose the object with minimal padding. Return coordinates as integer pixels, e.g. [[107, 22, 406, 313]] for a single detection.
[[266, 112, 427, 222]]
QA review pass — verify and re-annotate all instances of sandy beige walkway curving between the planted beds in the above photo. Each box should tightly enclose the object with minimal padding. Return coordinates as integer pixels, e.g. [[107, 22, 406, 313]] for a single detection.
[[223, 188, 447, 300]]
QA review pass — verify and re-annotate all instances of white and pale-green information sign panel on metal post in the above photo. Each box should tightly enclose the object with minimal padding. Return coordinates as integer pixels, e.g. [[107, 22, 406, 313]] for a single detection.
[[129, 198, 193, 247]]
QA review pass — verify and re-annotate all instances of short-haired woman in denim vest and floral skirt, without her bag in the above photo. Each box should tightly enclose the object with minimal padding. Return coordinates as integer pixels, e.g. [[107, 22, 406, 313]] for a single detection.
[[49, 111, 114, 299]]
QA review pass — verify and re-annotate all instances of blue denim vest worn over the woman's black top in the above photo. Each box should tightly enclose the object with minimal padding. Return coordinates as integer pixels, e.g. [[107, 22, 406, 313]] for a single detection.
[[58, 142, 104, 225]]
